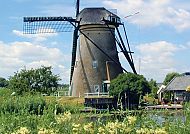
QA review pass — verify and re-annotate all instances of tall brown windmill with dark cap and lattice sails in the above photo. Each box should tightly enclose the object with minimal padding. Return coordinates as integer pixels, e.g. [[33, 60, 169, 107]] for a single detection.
[[23, 0, 136, 96]]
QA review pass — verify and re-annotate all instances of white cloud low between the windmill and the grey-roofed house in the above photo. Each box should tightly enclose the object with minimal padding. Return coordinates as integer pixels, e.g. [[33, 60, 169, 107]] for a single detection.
[[135, 41, 180, 82]]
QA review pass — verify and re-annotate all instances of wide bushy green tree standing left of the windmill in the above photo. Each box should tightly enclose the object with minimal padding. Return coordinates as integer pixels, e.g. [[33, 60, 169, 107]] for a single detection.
[[9, 66, 60, 94]]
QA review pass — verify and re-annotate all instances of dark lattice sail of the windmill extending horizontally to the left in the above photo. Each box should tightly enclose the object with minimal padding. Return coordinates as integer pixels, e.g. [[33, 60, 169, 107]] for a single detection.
[[23, 17, 75, 34]]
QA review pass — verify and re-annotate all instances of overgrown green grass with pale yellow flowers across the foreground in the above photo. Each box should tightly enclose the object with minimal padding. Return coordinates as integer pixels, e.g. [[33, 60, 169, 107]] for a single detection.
[[0, 89, 190, 134]]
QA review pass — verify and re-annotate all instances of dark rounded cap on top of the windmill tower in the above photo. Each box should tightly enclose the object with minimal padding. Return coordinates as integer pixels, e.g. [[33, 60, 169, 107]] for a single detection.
[[77, 7, 120, 25]]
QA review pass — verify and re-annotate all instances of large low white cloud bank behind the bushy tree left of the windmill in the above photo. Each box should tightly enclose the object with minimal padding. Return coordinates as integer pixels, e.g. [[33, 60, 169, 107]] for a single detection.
[[0, 42, 70, 83]]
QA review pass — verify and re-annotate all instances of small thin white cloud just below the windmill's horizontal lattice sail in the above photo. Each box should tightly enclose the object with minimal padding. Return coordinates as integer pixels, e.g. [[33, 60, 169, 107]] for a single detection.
[[12, 29, 58, 42]]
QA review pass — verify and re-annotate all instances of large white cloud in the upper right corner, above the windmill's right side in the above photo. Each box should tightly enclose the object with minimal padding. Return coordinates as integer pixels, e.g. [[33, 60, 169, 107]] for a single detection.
[[104, 0, 190, 31]]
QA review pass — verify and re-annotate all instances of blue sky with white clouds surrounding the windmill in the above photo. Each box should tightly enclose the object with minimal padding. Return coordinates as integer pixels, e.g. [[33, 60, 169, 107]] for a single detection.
[[0, 0, 190, 83]]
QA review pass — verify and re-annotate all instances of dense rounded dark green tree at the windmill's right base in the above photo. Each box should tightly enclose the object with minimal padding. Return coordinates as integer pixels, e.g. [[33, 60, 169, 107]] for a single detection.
[[109, 73, 151, 108]]
